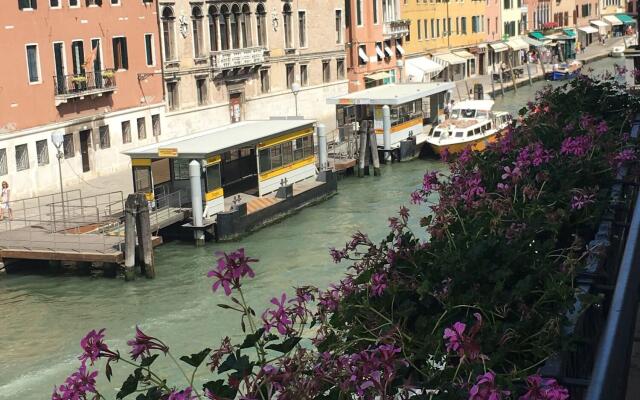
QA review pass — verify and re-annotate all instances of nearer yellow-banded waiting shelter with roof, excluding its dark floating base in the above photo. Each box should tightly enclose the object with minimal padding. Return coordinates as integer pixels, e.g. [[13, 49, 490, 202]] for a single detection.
[[124, 119, 317, 218]]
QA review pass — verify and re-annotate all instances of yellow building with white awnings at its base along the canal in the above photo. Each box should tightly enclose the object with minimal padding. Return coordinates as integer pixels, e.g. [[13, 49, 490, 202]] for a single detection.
[[400, 0, 487, 81]]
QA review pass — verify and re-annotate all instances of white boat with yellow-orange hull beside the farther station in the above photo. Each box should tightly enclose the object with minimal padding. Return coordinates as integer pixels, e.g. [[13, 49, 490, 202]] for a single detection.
[[427, 100, 511, 154]]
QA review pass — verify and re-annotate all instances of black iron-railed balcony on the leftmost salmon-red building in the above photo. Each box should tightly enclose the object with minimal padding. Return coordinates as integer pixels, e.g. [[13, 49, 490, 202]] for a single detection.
[[53, 69, 116, 107]]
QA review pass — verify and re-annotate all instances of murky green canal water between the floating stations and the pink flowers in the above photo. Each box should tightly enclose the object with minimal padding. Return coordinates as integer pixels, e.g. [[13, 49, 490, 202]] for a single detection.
[[0, 60, 613, 399]]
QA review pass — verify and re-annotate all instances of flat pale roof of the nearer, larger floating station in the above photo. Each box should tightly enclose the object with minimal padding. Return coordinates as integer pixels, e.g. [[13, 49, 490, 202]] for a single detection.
[[123, 119, 316, 159]]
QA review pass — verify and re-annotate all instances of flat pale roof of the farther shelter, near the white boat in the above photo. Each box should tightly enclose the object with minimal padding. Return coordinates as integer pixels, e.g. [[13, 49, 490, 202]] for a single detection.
[[327, 82, 456, 105]]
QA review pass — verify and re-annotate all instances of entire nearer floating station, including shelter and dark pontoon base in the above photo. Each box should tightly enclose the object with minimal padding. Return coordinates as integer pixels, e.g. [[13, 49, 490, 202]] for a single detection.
[[124, 118, 337, 243]]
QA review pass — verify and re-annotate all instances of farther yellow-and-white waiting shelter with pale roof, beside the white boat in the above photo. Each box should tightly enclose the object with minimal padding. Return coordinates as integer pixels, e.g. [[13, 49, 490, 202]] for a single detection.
[[327, 82, 455, 159]]
